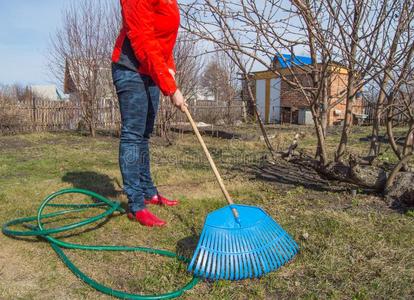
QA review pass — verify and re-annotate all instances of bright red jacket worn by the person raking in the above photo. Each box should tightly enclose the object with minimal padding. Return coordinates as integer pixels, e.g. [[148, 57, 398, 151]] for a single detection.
[[112, 0, 180, 96]]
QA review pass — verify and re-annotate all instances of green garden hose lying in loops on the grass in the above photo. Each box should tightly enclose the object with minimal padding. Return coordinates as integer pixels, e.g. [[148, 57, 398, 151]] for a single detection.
[[2, 189, 199, 300]]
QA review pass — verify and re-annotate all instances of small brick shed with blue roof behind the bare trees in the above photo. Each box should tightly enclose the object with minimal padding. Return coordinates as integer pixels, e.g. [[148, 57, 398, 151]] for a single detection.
[[247, 55, 364, 125]]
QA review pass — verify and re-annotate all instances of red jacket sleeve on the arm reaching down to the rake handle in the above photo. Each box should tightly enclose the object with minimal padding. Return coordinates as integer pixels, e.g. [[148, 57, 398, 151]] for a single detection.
[[121, 0, 177, 96]]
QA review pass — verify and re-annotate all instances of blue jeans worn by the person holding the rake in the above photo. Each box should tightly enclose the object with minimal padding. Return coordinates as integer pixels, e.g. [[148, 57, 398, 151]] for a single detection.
[[112, 64, 160, 212]]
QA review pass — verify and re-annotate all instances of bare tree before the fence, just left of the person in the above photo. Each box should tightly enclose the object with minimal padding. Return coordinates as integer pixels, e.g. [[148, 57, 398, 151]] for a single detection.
[[49, 0, 119, 136]]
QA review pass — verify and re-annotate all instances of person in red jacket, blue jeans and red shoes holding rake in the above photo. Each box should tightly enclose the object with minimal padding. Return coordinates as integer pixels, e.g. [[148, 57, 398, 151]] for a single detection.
[[112, 0, 187, 227]]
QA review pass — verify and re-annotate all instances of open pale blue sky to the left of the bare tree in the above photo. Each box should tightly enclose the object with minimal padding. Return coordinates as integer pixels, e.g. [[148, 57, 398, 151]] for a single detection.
[[0, 0, 84, 84]]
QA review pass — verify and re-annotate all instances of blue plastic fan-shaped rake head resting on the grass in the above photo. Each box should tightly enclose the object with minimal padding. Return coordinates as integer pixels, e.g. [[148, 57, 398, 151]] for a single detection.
[[188, 205, 299, 280]]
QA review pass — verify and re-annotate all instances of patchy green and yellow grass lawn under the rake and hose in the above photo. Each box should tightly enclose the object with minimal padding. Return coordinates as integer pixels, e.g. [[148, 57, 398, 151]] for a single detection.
[[0, 127, 414, 299]]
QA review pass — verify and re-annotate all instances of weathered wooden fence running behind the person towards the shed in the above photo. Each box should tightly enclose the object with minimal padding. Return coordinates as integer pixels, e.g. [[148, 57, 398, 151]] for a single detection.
[[0, 98, 244, 134]]
